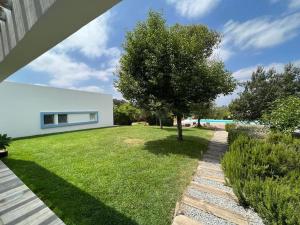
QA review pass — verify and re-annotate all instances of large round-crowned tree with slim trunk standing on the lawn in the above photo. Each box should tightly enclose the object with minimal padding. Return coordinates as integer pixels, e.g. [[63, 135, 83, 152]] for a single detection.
[[115, 11, 235, 140]]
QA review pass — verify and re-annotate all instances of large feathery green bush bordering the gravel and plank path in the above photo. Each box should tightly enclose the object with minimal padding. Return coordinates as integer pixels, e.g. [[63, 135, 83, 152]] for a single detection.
[[222, 130, 300, 225]]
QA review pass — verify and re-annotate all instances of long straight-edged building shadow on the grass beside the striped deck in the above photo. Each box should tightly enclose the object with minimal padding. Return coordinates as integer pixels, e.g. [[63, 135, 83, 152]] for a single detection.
[[3, 158, 137, 225]]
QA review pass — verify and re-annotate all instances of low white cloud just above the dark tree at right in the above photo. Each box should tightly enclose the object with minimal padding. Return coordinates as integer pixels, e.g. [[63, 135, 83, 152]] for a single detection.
[[232, 60, 300, 81]]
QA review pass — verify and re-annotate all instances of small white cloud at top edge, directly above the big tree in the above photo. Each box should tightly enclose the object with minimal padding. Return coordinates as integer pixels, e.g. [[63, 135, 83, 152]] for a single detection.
[[167, 0, 221, 18]]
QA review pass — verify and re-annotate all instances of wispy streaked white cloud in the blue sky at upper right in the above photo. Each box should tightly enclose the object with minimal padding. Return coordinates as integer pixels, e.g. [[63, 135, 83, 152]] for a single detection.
[[224, 13, 300, 49]]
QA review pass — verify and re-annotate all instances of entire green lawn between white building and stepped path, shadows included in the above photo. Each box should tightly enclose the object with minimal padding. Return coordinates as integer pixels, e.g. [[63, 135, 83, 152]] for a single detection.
[[3, 125, 212, 225]]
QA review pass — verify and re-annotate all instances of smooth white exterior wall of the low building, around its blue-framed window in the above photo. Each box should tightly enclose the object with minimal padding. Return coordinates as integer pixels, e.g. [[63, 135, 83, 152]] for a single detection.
[[0, 82, 113, 138]]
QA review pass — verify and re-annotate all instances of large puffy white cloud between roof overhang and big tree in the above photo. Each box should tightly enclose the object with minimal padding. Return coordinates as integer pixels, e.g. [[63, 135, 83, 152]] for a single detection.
[[29, 13, 121, 92]]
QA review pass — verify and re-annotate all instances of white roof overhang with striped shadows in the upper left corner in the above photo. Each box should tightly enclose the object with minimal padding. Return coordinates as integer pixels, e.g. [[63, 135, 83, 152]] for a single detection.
[[0, 0, 120, 82]]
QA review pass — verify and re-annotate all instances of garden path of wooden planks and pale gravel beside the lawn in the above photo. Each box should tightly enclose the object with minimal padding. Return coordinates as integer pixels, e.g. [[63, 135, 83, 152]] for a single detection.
[[173, 131, 263, 225]]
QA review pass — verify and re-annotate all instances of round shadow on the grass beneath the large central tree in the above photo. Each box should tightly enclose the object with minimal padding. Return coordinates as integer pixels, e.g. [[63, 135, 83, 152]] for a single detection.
[[144, 135, 209, 159]]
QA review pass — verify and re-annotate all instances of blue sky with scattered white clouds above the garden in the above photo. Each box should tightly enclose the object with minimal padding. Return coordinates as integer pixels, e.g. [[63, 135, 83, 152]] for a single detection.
[[8, 0, 300, 105]]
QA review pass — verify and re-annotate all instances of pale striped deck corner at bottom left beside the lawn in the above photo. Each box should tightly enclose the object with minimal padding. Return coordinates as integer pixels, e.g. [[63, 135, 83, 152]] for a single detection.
[[0, 161, 64, 225]]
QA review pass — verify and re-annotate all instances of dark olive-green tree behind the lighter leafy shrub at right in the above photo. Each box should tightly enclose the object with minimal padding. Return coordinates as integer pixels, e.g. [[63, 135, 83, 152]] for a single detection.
[[229, 64, 300, 120]]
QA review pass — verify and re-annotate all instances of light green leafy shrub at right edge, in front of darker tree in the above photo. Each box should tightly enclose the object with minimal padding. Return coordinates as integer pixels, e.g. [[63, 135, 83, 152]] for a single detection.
[[263, 96, 300, 133]]
